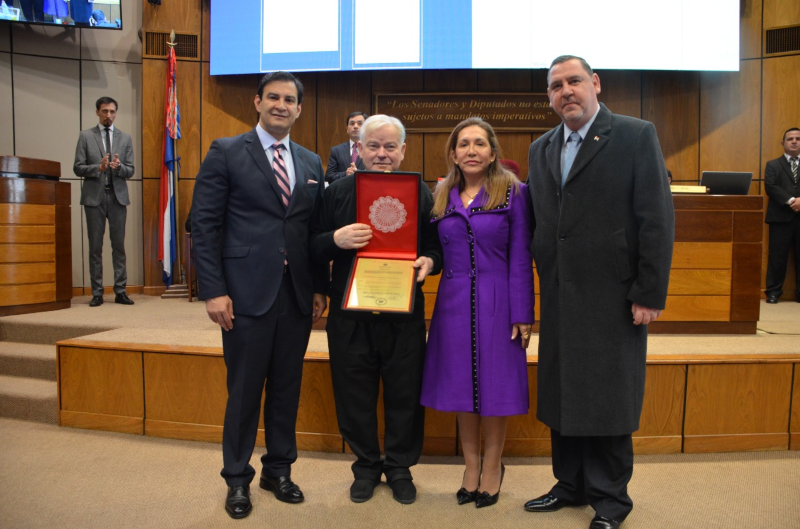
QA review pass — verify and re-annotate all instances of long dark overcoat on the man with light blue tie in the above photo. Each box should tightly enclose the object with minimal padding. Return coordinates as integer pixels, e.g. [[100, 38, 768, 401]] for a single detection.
[[528, 102, 675, 436]]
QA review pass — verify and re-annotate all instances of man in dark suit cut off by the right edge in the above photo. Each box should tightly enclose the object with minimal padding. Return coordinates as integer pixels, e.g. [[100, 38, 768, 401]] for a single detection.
[[764, 127, 800, 303]]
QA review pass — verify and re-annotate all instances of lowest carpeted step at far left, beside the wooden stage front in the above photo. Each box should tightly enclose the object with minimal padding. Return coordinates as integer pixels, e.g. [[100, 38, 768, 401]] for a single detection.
[[0, 375, 58, 424]]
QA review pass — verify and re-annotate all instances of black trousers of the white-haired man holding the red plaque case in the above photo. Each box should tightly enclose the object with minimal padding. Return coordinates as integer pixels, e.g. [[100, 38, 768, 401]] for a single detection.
[[326, 316, 425, 482]]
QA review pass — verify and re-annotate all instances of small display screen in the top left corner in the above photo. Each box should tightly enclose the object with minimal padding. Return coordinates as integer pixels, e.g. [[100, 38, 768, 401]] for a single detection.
[[0, 0, 122, 29]]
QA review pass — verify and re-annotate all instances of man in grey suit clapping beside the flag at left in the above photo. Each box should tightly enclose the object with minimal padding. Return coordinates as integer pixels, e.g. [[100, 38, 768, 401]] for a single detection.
[[73, 97, 133, 307]]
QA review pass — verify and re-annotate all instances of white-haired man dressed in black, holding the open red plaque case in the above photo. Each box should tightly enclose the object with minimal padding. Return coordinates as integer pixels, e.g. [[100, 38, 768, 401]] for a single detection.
[[311, 114, 442, 504]]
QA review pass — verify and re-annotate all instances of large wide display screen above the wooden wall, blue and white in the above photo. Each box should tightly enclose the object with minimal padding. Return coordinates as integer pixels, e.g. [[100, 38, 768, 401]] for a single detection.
[[209, 0, 740, 75]]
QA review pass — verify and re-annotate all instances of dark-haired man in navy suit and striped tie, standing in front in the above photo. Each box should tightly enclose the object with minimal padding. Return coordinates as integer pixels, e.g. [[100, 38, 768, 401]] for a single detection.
[[192, 72, 328, 518]]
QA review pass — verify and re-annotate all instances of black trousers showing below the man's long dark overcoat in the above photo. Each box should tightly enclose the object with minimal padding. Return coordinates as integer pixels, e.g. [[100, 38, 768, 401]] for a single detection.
[[550, 430, 633, 522]]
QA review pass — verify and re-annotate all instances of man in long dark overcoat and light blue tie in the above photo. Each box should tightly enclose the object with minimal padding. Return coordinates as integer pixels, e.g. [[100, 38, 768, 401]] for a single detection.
[[525, 56, 674, 529]]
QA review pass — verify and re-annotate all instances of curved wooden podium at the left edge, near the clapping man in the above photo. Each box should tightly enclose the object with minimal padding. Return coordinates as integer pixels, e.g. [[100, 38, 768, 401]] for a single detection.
[[0, 156, 72, 316]]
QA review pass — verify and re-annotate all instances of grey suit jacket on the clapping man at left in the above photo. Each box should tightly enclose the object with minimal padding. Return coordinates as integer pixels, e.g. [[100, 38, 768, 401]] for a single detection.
[[72, 125, 134, 206]]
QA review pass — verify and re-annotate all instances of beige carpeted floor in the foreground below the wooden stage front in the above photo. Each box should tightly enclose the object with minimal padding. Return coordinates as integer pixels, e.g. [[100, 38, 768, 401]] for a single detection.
[[0, 419, 800, 529]]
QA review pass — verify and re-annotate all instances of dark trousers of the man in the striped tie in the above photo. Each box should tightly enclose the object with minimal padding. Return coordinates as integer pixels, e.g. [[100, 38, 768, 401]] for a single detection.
[[220, 274, 311, 487]]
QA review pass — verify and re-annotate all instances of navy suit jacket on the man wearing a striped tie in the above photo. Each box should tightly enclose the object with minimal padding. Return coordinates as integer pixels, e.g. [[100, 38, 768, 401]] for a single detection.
[[192, 129, 328, 316]]
